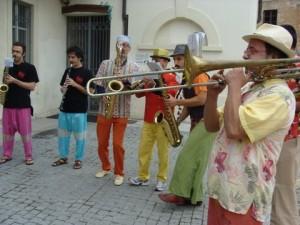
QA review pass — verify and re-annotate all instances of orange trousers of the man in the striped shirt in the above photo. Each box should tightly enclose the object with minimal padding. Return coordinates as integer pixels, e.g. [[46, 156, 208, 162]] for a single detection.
[[97, 115, 128, 176]]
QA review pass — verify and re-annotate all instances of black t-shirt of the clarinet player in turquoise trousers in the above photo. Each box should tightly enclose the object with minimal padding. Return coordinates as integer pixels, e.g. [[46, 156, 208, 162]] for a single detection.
[[60, 67, 93, 113]]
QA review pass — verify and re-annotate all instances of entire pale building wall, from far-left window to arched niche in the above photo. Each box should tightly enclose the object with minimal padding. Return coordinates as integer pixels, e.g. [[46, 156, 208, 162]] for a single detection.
[[0, 0, 258, 118]]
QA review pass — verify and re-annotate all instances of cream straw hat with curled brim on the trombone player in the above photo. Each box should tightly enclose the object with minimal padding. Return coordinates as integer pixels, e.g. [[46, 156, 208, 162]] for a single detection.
[[243, 23, 295, 58]]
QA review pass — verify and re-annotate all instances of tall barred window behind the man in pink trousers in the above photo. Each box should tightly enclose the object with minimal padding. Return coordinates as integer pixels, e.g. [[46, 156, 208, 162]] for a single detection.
[[12, 0, 32, 62]]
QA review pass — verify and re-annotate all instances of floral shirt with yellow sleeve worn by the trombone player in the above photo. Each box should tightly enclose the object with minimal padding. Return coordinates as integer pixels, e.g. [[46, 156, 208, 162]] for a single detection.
[[208, 79, 295, 222]]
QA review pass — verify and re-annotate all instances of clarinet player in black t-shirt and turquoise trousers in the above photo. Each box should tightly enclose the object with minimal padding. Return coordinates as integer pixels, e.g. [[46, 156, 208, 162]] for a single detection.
[[52, 46, 92, 169]]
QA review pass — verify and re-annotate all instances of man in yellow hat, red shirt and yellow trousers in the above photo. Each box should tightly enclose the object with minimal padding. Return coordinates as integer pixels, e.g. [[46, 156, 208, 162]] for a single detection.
[[129, 48, 178, 191]]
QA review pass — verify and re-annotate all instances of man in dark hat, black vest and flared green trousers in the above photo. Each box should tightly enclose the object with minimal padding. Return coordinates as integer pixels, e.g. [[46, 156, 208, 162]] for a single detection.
[[159, 44, 214, 205]]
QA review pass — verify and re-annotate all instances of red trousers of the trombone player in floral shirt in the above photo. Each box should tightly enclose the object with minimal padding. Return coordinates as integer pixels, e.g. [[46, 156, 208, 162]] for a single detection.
[[207, 198, 262, 225]]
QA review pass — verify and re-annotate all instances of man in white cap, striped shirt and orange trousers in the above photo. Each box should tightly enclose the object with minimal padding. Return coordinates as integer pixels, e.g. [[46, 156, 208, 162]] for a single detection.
[[96, 35, 139, 186]]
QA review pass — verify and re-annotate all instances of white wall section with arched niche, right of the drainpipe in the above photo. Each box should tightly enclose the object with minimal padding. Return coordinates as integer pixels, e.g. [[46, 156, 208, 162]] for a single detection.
[[127, 0, 258, 118]]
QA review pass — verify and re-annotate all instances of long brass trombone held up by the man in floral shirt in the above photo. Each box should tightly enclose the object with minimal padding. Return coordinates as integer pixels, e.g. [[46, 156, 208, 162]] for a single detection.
[[86, 48, 300, 97]]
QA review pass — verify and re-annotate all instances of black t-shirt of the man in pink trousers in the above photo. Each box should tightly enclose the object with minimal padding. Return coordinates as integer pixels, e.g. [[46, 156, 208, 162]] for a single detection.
[[4, 62, 39, 108]]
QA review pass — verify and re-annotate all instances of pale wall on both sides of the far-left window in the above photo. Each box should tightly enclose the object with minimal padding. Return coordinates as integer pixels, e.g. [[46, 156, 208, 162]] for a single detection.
[[0, 0, 66, 117]]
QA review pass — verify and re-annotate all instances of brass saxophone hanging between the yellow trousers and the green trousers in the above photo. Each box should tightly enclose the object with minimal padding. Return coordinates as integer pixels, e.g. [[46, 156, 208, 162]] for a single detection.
[[154, 76, 182, 147]]
